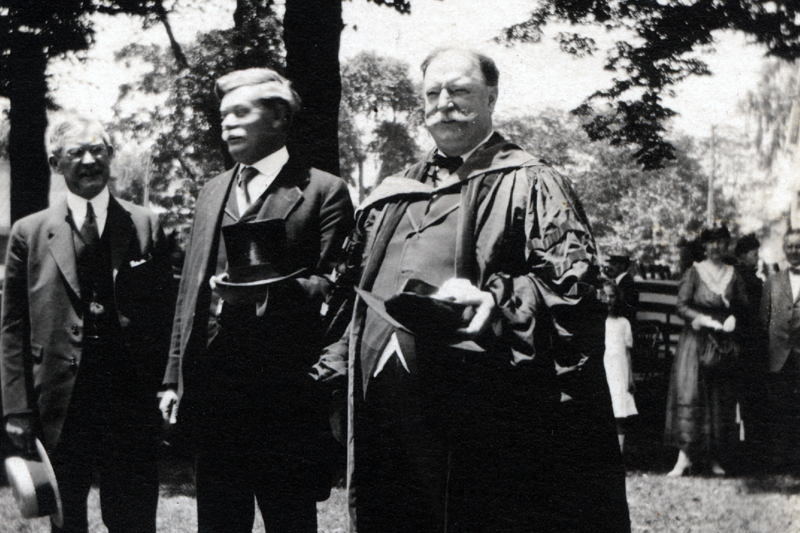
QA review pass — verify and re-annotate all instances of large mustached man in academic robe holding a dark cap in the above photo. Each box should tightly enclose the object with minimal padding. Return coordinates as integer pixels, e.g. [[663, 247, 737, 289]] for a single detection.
[[315, 49, 630, 533]]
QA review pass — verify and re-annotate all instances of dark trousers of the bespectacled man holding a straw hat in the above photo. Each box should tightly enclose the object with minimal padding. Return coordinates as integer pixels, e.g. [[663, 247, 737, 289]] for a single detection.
[[49, 336, 160, 533]]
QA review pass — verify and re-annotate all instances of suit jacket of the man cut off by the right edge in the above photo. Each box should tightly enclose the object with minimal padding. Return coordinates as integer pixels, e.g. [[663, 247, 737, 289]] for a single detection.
[[761, 269, 800, 372]]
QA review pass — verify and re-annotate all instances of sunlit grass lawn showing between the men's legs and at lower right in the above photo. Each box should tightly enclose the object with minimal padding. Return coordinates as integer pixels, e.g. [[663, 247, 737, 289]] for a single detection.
[[0, 472, 800, 533]]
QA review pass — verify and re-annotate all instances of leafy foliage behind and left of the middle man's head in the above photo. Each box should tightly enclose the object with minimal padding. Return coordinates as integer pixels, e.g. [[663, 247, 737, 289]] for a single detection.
[[113, 0, 284, 226]]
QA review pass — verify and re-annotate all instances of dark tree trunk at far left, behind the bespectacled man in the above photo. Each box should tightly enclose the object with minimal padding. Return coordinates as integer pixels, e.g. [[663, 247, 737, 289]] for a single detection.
[[8, 35, 50, 224]]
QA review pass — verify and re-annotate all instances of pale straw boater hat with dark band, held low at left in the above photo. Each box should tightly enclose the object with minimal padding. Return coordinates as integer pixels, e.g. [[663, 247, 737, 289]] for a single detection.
[[5, 439, 64, 527]]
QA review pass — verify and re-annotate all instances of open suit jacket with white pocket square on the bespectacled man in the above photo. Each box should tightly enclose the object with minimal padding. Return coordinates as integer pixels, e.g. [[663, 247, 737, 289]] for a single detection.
[[0, 196, 172, 448]]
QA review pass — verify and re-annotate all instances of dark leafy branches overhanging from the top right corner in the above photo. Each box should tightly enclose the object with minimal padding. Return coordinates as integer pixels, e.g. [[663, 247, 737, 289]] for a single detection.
[[500, 0, 800, 169]]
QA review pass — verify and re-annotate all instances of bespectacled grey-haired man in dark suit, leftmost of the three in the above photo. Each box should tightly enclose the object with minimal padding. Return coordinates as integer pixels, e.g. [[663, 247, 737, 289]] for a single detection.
[[0, 117, 172, 532]]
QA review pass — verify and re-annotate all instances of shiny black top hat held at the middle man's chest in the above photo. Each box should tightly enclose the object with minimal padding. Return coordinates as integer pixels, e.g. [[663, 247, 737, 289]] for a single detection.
[[211, 219, 306, 303]]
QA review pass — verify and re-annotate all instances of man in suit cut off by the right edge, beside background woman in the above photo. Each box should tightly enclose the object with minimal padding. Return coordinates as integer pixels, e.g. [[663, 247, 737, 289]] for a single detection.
[[761, 229, 800, 468]]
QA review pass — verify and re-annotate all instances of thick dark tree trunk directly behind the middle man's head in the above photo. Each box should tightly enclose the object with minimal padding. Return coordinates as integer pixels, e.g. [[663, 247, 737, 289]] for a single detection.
[[283, 0, 343, 176]]
